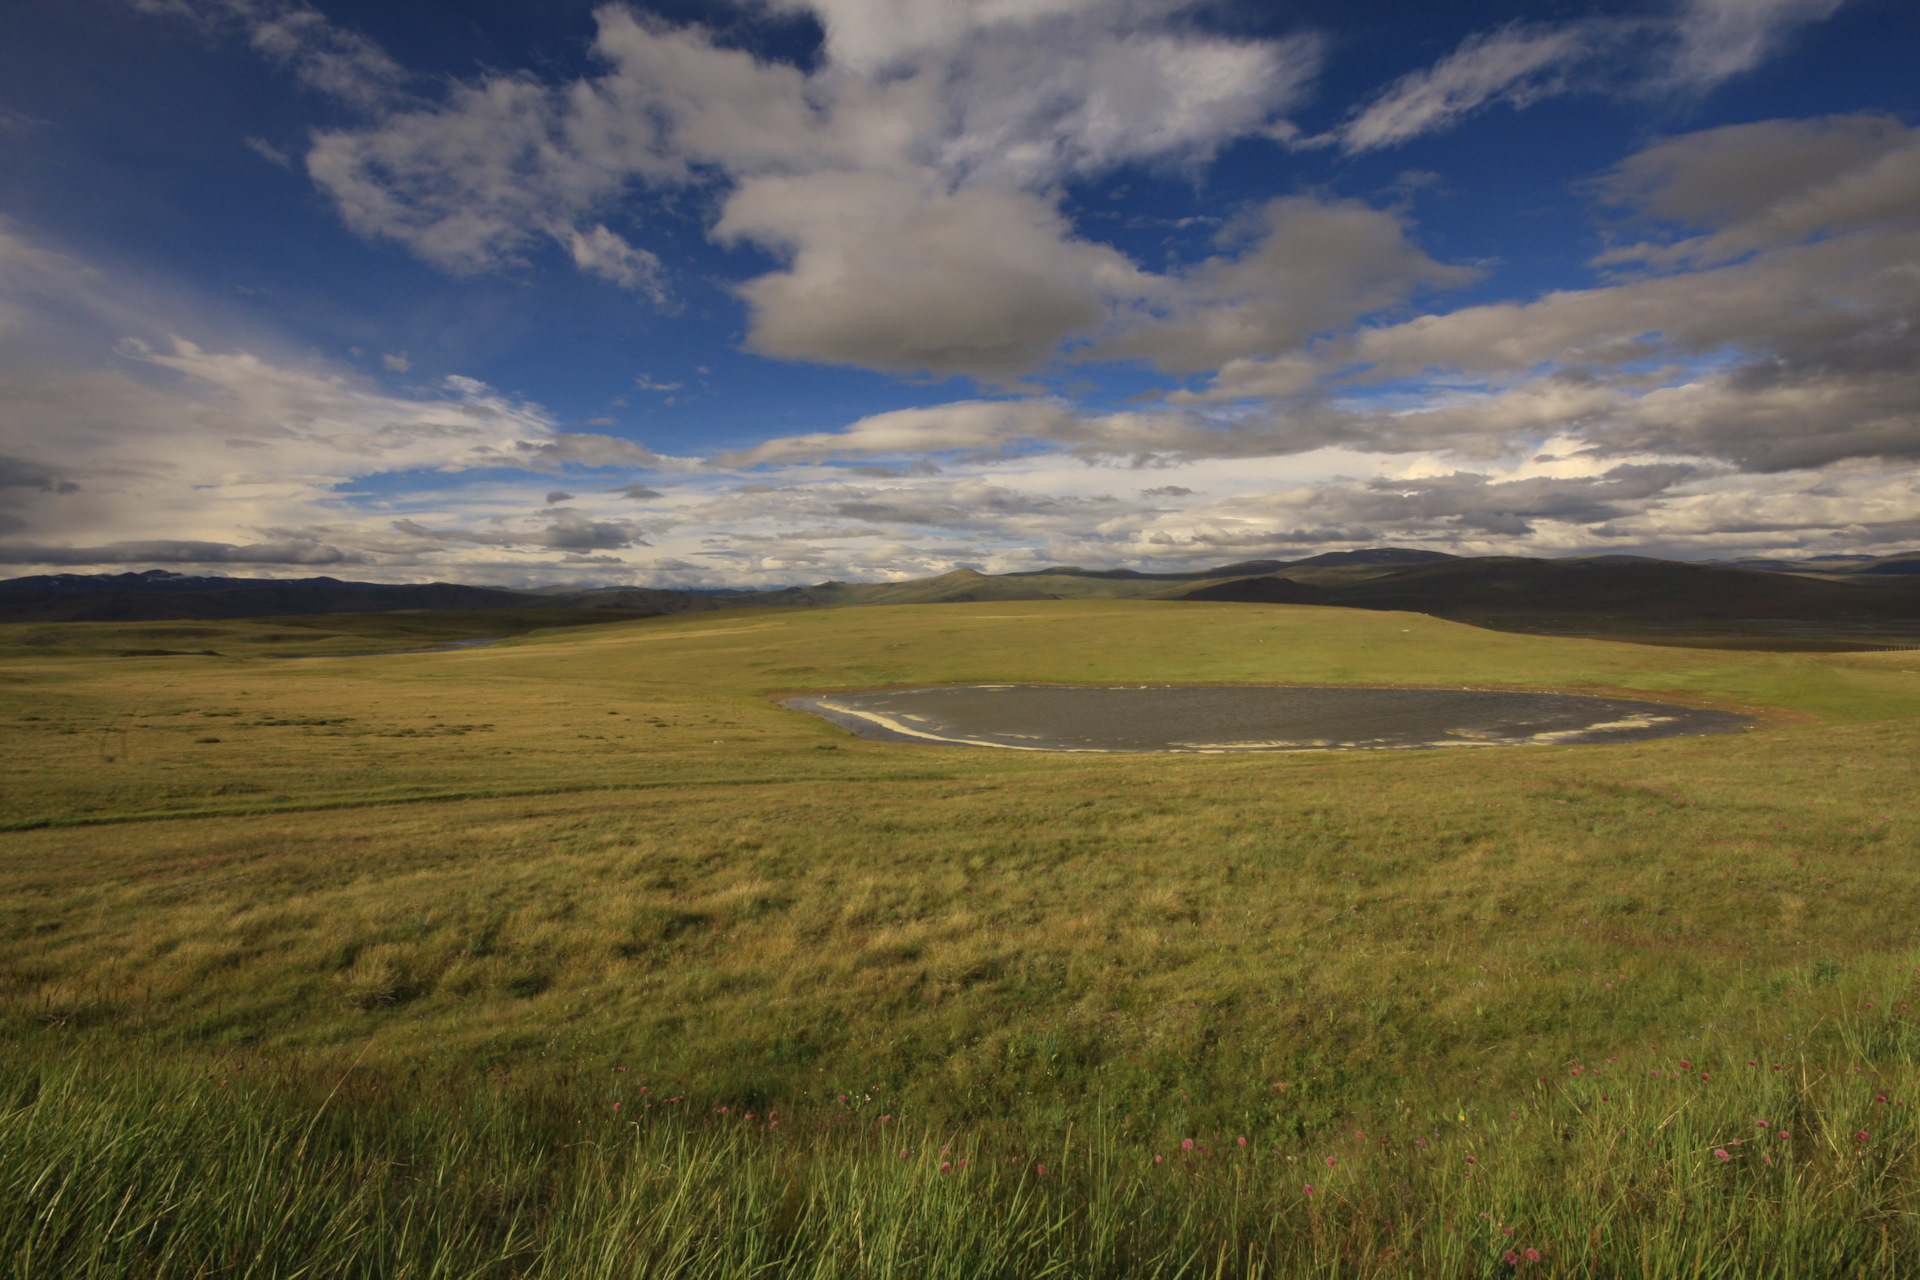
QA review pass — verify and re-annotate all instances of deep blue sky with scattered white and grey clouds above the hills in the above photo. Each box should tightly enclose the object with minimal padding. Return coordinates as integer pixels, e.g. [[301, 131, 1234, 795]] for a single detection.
[[0, 0, 1920, 587]]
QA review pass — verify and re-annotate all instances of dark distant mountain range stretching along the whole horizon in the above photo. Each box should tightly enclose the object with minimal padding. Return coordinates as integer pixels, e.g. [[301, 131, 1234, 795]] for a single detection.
[[0, 547, 1920, 633]]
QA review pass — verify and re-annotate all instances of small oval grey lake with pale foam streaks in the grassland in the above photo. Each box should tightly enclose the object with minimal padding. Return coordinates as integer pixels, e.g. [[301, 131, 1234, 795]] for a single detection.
[[781, 685, 1753, 752]]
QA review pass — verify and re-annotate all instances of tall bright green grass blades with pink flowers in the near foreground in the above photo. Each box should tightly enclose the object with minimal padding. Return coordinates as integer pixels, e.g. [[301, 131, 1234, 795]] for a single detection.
[[0, 1054, 1920, 1280]]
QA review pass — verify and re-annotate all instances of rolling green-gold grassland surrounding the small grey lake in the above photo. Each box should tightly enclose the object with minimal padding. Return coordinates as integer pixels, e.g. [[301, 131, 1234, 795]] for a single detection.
[[0, 601, 1920, 1276]]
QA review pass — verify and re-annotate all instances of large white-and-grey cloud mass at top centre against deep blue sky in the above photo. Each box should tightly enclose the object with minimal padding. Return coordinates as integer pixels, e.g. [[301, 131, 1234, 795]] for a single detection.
[[168, 0, 1321, 382]]
